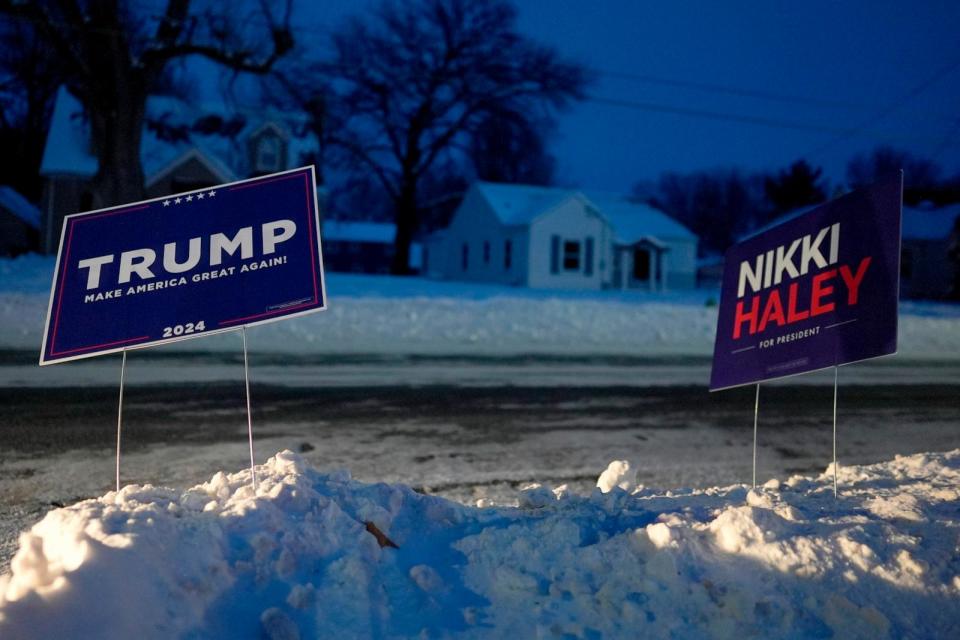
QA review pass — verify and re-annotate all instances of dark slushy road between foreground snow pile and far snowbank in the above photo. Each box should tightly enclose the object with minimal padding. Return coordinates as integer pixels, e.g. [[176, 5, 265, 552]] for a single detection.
[[0, 381, 960, 566]]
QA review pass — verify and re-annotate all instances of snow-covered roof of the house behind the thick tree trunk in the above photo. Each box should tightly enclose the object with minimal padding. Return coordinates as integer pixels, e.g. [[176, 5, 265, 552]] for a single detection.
[[40, 87, 314, 183]]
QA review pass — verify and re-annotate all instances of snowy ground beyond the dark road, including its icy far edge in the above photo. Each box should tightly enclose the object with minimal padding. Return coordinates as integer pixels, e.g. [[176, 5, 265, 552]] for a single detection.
[[0, 256, 960, 387]]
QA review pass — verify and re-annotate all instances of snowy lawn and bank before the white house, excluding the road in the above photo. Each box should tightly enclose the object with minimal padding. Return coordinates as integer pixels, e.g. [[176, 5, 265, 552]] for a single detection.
[[0, 256, 960, 360]]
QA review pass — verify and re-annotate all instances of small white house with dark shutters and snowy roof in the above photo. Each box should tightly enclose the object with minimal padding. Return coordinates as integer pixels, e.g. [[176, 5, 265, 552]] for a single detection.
[[423, 182, 697, 290]]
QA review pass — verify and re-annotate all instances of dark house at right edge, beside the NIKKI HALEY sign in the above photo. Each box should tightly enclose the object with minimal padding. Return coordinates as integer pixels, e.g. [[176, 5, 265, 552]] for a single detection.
[[900, 204, 960, 299]]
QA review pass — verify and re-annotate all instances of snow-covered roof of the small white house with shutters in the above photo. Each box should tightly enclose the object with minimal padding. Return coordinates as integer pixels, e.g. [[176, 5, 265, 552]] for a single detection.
[[476, 182, 696, 244]]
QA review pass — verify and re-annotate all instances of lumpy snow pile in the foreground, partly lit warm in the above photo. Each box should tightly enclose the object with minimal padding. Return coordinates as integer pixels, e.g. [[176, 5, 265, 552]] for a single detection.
[[0, 450, 960, 638]]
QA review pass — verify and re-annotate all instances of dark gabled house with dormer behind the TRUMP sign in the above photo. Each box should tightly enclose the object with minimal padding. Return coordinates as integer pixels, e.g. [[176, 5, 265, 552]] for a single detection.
[[40, 88, 316, 253]]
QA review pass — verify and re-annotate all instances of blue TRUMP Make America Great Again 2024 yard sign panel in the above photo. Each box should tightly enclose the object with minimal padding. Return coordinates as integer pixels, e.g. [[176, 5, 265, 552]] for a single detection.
[[40, 167, 325, 365]]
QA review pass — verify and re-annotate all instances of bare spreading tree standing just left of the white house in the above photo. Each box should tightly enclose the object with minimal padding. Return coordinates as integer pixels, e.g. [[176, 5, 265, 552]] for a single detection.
[[319, 0, 586, 273]]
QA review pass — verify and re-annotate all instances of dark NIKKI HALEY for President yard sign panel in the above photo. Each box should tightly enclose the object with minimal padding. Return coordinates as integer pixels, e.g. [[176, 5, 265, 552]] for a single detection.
[[710, 174, 903, 391]]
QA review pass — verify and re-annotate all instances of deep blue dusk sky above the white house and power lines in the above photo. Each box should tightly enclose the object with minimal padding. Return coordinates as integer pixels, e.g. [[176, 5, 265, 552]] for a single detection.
[[256, 0, 960, 191]]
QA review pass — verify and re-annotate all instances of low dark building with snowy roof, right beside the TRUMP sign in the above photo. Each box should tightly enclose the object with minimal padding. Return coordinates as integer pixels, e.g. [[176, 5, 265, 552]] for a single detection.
[[321, 220, 421, 273]]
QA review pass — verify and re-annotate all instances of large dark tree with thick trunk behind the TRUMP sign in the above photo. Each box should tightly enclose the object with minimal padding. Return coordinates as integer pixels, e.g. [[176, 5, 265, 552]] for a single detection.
[[0, 0, 293, 206]]
